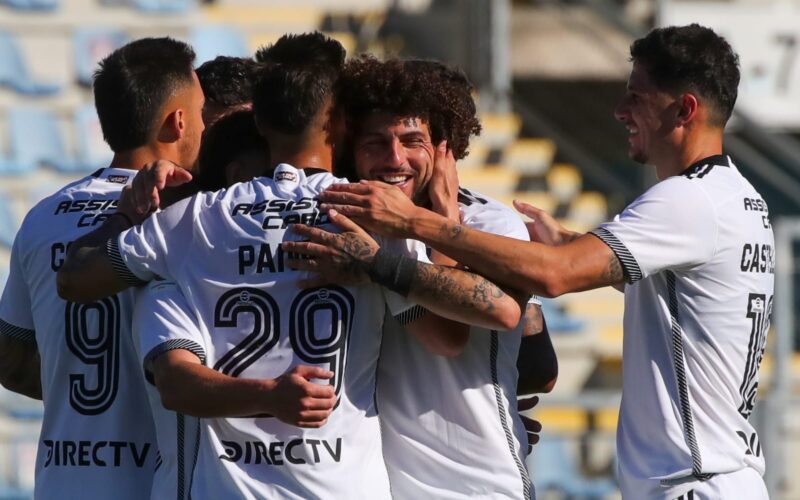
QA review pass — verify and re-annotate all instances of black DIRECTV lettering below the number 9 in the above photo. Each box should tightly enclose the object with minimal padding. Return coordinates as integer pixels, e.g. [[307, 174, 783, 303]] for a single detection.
[[42, 439, 151, 468]]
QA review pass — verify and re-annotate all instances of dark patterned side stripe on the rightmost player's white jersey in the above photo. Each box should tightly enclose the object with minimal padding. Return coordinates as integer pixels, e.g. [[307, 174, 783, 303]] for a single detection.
[[664, 271, 703, 478]]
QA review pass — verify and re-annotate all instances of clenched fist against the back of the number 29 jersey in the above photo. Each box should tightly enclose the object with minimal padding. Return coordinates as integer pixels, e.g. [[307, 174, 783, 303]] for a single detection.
[[267, 365, 336, 428]]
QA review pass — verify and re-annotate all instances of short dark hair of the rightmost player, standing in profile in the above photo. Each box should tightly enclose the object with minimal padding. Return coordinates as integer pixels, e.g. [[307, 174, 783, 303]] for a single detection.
[[631, 24, 739, 127]]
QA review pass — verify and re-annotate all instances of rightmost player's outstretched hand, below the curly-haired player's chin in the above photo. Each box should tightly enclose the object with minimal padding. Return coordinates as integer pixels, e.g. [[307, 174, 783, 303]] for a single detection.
[[319, 181, 417, 238]]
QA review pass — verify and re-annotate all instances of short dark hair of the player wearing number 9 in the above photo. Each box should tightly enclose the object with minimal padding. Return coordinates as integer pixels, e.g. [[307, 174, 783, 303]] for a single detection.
[[94, 37, 195, 153]]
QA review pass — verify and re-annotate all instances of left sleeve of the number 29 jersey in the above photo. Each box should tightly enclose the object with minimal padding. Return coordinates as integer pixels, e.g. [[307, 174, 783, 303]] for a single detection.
[[107, 196, 197, 285]]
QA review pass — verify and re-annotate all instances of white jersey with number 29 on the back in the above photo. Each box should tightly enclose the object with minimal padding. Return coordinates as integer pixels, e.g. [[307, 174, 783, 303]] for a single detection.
[[109, 164, 418, 499]]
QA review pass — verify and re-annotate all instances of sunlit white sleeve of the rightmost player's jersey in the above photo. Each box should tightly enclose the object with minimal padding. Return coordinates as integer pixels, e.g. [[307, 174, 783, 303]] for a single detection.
[[592, 177, 717, 282]]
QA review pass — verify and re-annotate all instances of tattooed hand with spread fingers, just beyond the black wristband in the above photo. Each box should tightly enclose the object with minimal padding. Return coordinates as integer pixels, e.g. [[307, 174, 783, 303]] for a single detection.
[[281, 210, 380, 279]]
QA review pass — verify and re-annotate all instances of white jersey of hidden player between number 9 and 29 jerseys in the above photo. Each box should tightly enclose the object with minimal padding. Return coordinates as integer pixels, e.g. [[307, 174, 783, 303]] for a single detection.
[[133, 280, 200, 500]]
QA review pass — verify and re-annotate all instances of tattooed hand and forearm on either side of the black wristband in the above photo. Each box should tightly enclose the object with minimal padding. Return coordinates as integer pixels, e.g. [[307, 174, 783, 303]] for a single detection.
[[282, 212, 527, 330]]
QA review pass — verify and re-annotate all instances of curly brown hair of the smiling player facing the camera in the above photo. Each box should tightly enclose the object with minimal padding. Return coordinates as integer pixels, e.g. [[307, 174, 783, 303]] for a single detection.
[[338, 55, 481, 159]]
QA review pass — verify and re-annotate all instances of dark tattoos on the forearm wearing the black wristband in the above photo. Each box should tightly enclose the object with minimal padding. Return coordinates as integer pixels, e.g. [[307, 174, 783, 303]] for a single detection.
[[411, 263, 505, 311]]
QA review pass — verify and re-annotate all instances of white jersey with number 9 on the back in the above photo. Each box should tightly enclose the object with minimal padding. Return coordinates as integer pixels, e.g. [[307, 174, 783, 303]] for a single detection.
[[0, 168, 157, 500]]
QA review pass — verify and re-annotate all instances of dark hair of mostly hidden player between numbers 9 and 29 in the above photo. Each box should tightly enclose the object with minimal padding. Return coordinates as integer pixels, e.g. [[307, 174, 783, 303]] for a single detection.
[[197, 56, 256, 106]]
